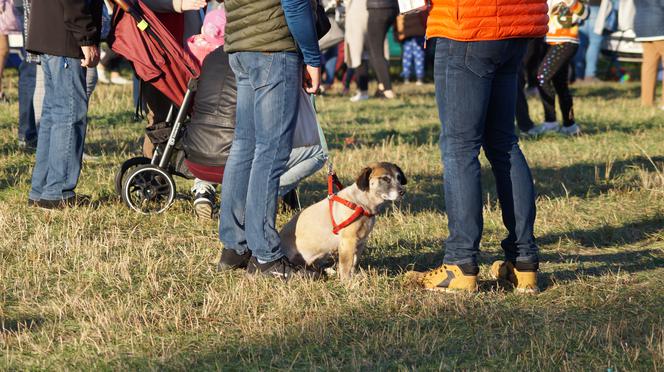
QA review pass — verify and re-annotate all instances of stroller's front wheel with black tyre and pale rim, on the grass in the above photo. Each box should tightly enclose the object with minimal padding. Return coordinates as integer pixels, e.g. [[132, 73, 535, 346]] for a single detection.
[[122, 165, 175, 214]]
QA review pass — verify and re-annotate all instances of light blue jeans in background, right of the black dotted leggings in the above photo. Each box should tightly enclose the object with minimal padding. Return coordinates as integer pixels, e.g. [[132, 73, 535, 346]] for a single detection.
[[574, 5, 604, 79]]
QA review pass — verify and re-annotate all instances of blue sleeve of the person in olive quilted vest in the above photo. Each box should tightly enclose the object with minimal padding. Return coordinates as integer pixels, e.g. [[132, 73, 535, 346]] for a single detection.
[[281, 0, 320, 67]]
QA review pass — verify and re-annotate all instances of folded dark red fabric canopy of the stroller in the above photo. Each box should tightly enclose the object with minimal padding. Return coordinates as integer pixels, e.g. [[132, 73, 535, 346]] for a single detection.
[[109, 0, 200, 106]]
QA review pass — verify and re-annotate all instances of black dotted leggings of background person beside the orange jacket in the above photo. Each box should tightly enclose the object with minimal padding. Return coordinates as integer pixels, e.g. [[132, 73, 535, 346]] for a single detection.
[[537, 43, 579, 127]]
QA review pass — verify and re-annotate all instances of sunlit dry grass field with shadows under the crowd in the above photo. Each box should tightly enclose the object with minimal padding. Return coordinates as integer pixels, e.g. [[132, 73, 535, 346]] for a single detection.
[[0, 75, 664, 371]]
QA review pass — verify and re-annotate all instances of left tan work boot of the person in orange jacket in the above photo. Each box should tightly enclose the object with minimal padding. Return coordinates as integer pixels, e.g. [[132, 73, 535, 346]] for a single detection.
[[407, 265, 479, 292]]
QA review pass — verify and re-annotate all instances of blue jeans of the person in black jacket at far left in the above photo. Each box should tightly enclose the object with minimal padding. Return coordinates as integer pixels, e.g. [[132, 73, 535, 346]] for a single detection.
[[29, 54, 88, 200]]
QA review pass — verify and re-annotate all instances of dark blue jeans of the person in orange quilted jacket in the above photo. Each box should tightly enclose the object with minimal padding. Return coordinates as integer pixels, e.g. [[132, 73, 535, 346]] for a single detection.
[[434, 38, 538, 265]]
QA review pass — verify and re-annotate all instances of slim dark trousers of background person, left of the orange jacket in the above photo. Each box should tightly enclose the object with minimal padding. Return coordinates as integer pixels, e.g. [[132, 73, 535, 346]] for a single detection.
[[360, 8, 399, 90]]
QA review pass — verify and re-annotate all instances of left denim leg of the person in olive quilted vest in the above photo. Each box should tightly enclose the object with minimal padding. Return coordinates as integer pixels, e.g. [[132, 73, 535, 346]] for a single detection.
[[219, 52, 256, 255]]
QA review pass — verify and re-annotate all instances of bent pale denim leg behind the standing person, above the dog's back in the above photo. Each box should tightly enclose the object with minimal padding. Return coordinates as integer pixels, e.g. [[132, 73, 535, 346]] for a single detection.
[[279, 145, 327, 197]]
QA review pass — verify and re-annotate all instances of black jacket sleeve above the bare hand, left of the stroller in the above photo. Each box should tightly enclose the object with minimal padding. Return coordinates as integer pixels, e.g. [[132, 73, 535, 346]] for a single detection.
[[59, 0, 101, 46]]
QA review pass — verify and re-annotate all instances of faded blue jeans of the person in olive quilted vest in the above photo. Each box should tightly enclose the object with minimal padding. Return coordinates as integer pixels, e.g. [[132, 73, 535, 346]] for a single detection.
[[219, 52, 302, 262]]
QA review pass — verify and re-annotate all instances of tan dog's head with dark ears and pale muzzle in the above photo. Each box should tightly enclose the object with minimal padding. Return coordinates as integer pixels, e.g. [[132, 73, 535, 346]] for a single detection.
[[355, 163, 408, 201]]
